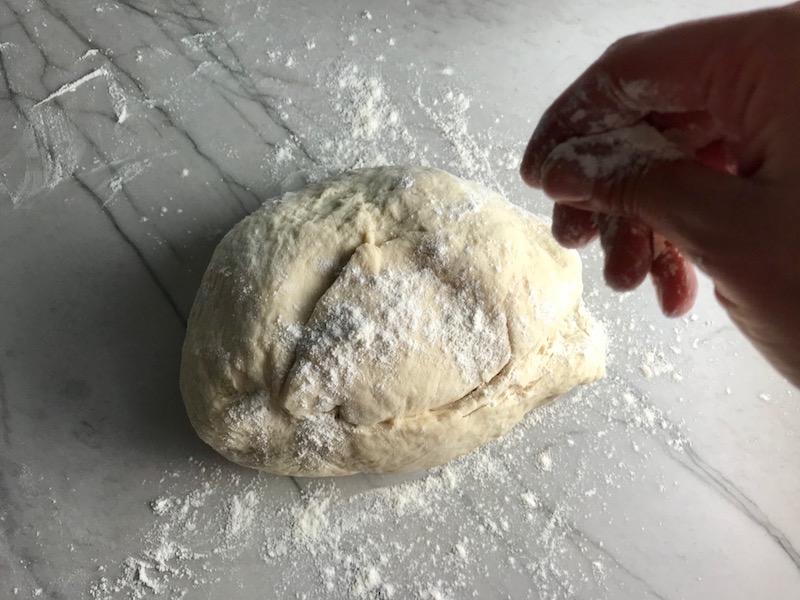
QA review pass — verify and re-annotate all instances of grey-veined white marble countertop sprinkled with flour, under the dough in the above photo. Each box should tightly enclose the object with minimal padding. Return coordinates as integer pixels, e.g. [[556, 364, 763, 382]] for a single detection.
[[0, 0, 800, 599]]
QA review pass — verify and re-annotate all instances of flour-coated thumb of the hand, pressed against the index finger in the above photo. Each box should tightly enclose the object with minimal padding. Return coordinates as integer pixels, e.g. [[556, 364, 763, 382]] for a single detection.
[[541, 136, 761, 267]]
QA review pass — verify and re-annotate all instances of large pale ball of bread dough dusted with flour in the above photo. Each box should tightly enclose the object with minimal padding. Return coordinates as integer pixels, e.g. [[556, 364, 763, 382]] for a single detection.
[[180, 167, 606, 476]]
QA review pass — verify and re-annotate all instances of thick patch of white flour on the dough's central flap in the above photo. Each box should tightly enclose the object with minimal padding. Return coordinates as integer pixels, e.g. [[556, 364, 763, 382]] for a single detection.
[[290, 268, 509, 422]]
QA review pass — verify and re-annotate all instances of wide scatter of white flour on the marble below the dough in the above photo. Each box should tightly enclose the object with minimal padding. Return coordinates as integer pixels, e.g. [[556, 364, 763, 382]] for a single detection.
[[91, 366, 686, 600]]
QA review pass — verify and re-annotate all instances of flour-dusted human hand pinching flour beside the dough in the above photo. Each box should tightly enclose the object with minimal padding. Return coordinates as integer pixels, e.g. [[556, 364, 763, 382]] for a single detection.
[[520, 3, 800, 384]]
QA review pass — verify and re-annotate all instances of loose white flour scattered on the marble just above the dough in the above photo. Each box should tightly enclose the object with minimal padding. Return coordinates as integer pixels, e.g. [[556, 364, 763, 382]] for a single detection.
[[238, 7, 522, 199]]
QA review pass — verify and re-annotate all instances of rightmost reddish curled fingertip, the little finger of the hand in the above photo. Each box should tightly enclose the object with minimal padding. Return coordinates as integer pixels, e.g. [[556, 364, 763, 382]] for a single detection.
[[650, 235, 697, 317]]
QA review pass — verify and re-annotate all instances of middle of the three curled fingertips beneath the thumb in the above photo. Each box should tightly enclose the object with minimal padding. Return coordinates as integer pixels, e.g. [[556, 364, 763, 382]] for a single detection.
[[598, 215, 653, 291]]
